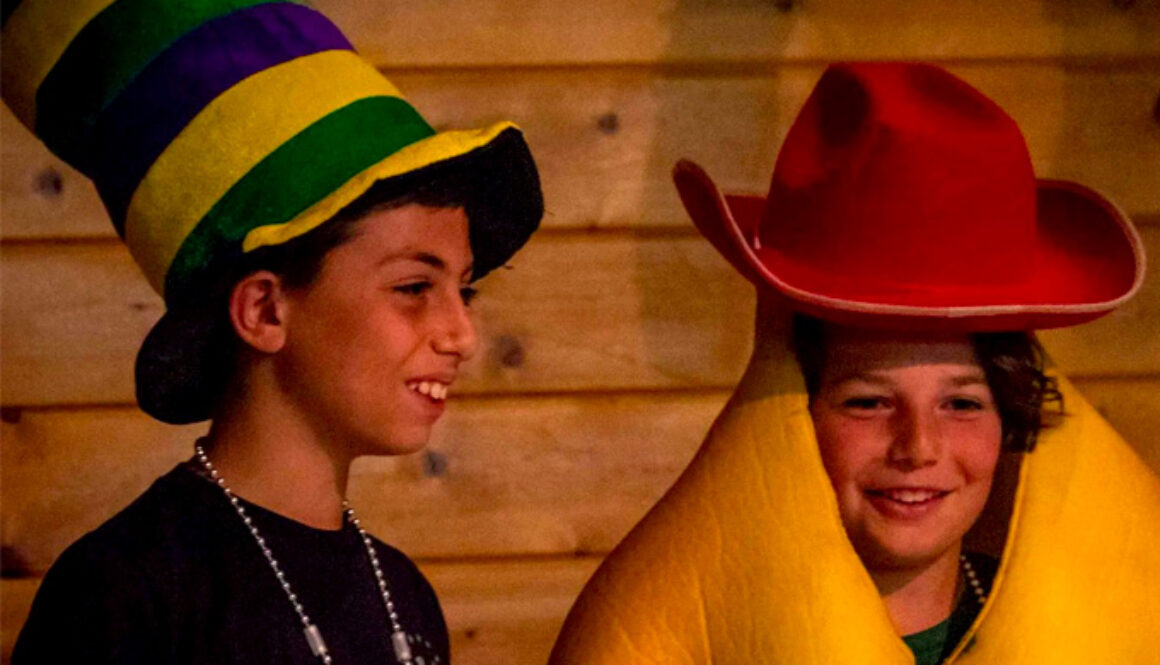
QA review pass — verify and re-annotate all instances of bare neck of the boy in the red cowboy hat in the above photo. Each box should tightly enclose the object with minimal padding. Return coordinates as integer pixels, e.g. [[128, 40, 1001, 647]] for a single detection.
[[869, 547, 960, 635]]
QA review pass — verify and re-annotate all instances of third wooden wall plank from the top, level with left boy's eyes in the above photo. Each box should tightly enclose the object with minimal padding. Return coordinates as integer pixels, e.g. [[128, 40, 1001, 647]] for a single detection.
[[0, 226, 1160, 406]]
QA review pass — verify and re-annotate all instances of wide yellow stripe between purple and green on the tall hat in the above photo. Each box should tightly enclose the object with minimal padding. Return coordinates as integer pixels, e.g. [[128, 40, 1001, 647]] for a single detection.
[[125, 51, 401, 292]]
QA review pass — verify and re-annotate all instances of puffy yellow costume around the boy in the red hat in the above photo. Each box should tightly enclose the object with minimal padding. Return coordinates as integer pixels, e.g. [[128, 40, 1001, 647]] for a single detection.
[[551, 297, 1160, 665]]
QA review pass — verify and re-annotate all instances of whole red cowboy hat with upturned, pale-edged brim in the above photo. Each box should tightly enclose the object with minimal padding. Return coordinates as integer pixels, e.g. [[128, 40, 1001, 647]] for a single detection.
[[673, 63, 1144, 332]]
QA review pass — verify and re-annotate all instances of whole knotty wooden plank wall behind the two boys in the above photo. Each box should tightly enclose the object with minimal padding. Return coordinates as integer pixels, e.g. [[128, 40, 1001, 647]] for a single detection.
[[0, 0, 1160, 665]]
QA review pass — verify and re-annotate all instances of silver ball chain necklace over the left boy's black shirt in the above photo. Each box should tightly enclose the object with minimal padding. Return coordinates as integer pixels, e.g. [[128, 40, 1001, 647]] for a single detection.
[[194, 443, 414, 665]]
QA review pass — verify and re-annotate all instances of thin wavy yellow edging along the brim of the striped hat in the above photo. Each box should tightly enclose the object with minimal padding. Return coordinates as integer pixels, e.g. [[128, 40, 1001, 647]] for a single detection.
[[242, 122, 515, 252]]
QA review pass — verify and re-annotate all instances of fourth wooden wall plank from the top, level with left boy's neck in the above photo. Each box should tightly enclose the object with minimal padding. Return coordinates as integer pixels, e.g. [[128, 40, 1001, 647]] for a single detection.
[[0, 377, 1160, 574]]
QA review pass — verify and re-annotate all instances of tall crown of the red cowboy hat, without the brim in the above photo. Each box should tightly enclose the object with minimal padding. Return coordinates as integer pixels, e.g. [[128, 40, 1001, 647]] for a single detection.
[[755, 65, 1036, 290]]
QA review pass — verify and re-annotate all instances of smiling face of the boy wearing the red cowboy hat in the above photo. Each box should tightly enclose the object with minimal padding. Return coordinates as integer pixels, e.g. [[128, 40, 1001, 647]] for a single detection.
[[810, 325, 1002, 572]]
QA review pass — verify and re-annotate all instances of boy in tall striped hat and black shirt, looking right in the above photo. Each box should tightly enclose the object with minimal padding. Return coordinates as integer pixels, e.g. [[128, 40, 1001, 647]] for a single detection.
[[2, 0, 543, 665]]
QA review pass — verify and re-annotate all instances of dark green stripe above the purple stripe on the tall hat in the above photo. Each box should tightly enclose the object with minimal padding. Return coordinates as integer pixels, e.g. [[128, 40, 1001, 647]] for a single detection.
[[36, 0, 303, 162]]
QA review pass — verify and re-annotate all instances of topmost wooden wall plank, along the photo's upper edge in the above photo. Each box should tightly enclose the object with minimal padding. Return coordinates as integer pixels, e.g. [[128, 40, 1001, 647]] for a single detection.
[[318, 0, 1160, 66]]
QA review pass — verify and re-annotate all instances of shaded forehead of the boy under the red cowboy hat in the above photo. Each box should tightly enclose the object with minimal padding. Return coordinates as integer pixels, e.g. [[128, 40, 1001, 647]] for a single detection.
[[825, 324, 979, 376]]
